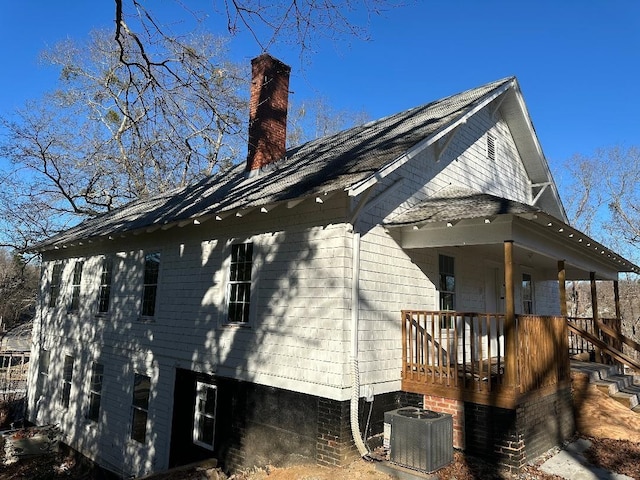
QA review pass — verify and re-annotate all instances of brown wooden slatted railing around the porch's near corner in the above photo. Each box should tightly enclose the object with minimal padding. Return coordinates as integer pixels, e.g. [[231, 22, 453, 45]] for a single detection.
[[402, 310, 570, 406]]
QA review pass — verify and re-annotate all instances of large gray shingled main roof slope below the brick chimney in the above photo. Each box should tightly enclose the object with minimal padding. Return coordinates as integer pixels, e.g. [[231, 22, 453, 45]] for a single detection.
[[33, 77, 513, 250]]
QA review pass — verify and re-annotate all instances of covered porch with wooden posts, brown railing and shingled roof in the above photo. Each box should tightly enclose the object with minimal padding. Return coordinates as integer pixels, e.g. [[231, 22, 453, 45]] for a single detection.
[[387, 191, 640, 409]]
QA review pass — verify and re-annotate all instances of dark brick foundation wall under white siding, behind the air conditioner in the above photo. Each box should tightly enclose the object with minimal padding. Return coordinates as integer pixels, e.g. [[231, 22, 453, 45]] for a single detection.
[[210, 378, 422, 472]]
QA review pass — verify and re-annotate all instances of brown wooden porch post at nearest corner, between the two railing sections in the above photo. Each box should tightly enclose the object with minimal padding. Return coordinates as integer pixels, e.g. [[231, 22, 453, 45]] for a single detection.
[[504, 240, 518, 387]]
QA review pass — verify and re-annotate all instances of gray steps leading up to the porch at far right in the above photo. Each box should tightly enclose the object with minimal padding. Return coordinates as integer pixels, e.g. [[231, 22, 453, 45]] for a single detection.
[[571, 360, 640, 414]]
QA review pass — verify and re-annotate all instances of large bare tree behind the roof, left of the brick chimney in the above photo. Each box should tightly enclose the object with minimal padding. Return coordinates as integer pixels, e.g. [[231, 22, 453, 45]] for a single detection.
[[0, 32, 247, 248]]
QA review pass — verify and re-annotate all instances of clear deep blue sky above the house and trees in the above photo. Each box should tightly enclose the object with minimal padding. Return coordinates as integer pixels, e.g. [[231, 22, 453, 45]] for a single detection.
[[0, 0, 640, 191]]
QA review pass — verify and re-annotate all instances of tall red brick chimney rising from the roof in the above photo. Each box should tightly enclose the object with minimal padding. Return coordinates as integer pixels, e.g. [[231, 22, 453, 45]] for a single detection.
[[246, 53, 291, 172]]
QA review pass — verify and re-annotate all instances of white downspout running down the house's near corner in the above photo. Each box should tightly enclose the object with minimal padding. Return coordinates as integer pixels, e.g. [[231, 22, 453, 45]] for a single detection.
[[350, 227, 369, 458]]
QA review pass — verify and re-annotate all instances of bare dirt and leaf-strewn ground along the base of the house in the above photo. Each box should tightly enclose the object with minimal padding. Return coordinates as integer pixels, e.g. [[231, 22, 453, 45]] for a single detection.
[[0, 376, 640, 480]]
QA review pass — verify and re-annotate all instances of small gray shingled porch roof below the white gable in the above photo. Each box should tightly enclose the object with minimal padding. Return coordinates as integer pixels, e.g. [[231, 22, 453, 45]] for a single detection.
[[385, 186, 540, 226]]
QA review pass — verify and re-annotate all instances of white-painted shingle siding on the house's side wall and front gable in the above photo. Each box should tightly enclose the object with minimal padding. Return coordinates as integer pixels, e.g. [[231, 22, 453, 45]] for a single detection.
[[29, 101, 551, 475]]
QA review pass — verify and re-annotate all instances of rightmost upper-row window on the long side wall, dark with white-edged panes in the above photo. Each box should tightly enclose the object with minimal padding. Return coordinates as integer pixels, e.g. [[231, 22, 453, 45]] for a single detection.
[[228, 243, 253, 323]]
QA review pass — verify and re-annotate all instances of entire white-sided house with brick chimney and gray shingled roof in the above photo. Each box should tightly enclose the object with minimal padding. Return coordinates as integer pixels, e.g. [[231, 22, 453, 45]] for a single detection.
[[28, 54, 638, 475]]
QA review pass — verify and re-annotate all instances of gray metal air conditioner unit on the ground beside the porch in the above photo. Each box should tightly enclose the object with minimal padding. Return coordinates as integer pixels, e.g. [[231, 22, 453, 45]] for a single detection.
[[384, 407, 453, 473]]
